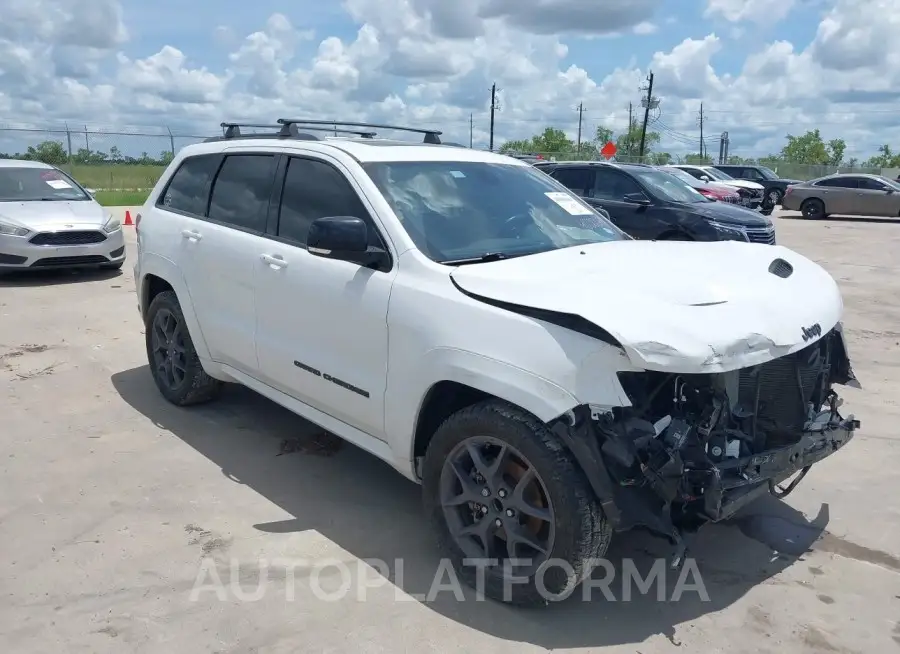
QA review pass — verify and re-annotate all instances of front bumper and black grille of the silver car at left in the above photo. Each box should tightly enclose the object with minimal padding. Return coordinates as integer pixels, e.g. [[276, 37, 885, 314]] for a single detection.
[[0, 227, 125, 271]]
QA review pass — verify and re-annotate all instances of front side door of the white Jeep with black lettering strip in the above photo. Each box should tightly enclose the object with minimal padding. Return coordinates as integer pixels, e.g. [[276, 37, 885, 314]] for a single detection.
[[255, 157, 396, 439]]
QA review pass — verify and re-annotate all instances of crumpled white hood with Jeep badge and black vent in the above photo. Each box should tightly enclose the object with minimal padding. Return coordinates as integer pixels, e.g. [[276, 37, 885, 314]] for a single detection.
[[451, 240, 843, 373]]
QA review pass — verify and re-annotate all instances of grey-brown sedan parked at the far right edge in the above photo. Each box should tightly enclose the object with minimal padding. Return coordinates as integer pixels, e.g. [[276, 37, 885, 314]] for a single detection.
[[782, 173, 900, 219]]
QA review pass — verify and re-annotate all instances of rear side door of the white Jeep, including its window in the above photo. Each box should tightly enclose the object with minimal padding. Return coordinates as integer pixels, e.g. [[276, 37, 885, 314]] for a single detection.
[[179, 152, 277, 375]]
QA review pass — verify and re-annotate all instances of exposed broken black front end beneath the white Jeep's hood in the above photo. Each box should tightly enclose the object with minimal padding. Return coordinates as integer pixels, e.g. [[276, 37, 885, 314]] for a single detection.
[[554, 325, 859, 554]]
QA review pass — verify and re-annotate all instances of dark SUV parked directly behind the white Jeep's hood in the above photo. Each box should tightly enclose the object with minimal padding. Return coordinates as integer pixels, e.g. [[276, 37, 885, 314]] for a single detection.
[[535, 161, 775, 244]]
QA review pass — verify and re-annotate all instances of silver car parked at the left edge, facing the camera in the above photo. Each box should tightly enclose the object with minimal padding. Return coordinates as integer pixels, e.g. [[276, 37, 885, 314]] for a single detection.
[[0, 159, 125, 271]]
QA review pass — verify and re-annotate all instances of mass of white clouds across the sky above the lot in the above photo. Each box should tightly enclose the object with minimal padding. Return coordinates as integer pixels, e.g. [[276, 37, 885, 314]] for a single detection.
[[0, 0, 900, 161]]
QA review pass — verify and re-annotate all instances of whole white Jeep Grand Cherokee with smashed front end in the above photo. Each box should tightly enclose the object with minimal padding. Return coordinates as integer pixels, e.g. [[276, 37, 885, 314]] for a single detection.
[[134, 120, 859, 604]]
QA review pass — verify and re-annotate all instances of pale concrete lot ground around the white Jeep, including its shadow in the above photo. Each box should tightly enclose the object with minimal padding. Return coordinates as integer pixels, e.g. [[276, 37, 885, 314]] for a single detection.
[[0, 213, 900, 654]]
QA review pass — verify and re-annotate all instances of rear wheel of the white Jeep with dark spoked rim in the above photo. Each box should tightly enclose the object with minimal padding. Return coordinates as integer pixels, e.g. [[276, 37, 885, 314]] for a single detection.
[[145, 291, 222, 406]]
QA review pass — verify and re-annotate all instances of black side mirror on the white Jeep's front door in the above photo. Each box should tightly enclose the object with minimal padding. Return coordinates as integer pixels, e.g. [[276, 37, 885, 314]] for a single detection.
[[306, 216, 391, 270]]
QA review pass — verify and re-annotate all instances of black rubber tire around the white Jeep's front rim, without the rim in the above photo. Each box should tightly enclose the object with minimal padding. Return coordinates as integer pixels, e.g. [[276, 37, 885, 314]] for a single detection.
[[422, 405, 609, 604]]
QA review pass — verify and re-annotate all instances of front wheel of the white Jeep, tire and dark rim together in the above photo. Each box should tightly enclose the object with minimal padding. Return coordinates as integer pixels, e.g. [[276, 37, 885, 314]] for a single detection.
[[422, 400, 612, 605]]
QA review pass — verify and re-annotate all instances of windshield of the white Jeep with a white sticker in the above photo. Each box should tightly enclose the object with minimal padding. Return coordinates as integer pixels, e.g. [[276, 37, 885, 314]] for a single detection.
[[363, 161, 628, 263]]
